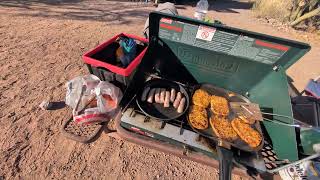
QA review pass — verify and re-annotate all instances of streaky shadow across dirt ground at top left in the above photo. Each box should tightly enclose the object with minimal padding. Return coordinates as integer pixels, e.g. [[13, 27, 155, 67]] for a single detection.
[[0, 0, 149, 24]]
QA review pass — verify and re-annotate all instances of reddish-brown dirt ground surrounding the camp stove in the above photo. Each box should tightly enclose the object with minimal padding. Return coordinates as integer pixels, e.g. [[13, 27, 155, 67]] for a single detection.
[[0, 0, 320, 179]]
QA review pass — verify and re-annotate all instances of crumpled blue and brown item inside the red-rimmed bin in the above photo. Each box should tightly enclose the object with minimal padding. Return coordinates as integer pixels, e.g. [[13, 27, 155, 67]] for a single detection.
[[116, 37, 137, 67]]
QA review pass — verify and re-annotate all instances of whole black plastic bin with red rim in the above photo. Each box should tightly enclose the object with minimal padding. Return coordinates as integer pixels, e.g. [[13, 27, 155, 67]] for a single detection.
[[82, 33, 148, 91]]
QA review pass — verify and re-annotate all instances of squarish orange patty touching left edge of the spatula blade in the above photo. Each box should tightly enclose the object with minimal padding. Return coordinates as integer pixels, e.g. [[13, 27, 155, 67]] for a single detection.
[[210, 95, 229, 116]]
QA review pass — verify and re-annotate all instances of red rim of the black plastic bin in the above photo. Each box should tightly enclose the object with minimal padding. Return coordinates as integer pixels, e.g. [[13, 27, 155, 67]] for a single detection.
[[82, 33, 148, 77]]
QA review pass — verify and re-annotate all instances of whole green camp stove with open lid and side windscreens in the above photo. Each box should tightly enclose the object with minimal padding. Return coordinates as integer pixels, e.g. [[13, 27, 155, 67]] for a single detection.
[[120, 12, 320, 172]]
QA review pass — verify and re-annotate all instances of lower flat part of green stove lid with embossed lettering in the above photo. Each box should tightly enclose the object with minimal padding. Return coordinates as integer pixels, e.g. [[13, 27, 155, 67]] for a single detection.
[[165, 41, 272, 94]]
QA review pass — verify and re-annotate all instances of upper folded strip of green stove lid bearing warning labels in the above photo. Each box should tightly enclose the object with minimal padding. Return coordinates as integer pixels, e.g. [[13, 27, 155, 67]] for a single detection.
[[149, 12, 311, 69]]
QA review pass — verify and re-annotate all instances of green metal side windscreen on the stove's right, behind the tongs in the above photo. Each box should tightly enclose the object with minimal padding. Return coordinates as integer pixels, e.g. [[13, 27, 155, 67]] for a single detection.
[[249, 68, 298, 161]]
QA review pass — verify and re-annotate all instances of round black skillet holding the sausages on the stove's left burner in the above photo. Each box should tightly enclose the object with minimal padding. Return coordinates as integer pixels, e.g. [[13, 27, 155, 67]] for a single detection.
[[136, 79, 190, 121]]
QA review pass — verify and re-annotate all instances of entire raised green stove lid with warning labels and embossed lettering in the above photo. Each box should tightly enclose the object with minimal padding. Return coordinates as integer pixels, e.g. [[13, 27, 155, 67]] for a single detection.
[[149, 12, 310, 94]]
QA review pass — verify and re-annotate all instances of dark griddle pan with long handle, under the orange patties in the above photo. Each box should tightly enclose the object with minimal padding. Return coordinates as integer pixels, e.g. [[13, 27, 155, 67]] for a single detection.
[[187, 84, 264, 180]]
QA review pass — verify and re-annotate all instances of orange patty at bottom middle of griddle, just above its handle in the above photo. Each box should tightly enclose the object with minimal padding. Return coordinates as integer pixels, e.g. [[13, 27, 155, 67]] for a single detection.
[[210, 116, 238, 141]]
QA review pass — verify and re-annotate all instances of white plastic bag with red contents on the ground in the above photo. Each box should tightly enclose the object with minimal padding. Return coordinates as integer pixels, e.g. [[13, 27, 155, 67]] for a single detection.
[[66, 75, 122, 124]]
